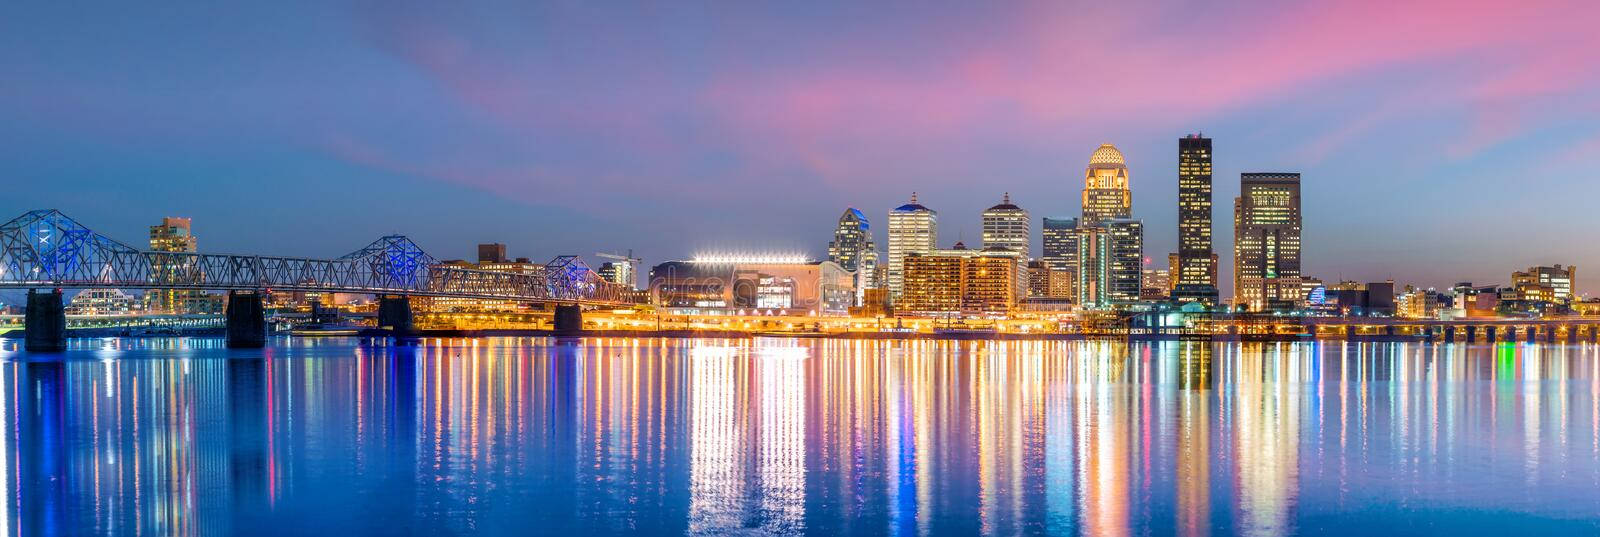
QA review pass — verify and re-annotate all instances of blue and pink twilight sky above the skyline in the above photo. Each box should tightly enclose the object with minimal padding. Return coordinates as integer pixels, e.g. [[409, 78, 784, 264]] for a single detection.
[[0, 2, 1600, 294]]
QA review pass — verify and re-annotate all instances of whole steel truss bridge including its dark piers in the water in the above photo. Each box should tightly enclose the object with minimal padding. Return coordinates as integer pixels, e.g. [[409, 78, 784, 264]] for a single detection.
[[0, 209, 629, 352]]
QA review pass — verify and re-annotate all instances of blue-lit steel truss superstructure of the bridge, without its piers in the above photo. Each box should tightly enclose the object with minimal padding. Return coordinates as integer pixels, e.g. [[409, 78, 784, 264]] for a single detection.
[[0, 209, 626, 304]]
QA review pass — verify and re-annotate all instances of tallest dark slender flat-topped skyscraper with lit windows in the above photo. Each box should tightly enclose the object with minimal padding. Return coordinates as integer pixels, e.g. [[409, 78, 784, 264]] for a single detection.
[[1173, 134, 1218, 304]]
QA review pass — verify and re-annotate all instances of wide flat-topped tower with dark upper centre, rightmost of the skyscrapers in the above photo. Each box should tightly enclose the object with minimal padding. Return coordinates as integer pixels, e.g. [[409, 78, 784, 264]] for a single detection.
[[1234, 173, 1304, 312]]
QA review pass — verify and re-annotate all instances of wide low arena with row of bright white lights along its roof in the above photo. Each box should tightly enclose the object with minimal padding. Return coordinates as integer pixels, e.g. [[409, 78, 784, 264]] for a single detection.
[[650, 256, 856, 315]]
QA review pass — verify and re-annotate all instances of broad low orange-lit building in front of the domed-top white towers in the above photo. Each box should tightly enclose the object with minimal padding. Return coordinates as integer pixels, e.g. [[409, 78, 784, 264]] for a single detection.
[[894, 243, 1026, 315]]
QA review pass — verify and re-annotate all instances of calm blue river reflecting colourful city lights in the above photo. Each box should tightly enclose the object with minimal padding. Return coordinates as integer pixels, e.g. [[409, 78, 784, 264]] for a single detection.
[[0, 339, 1600, 535]]
